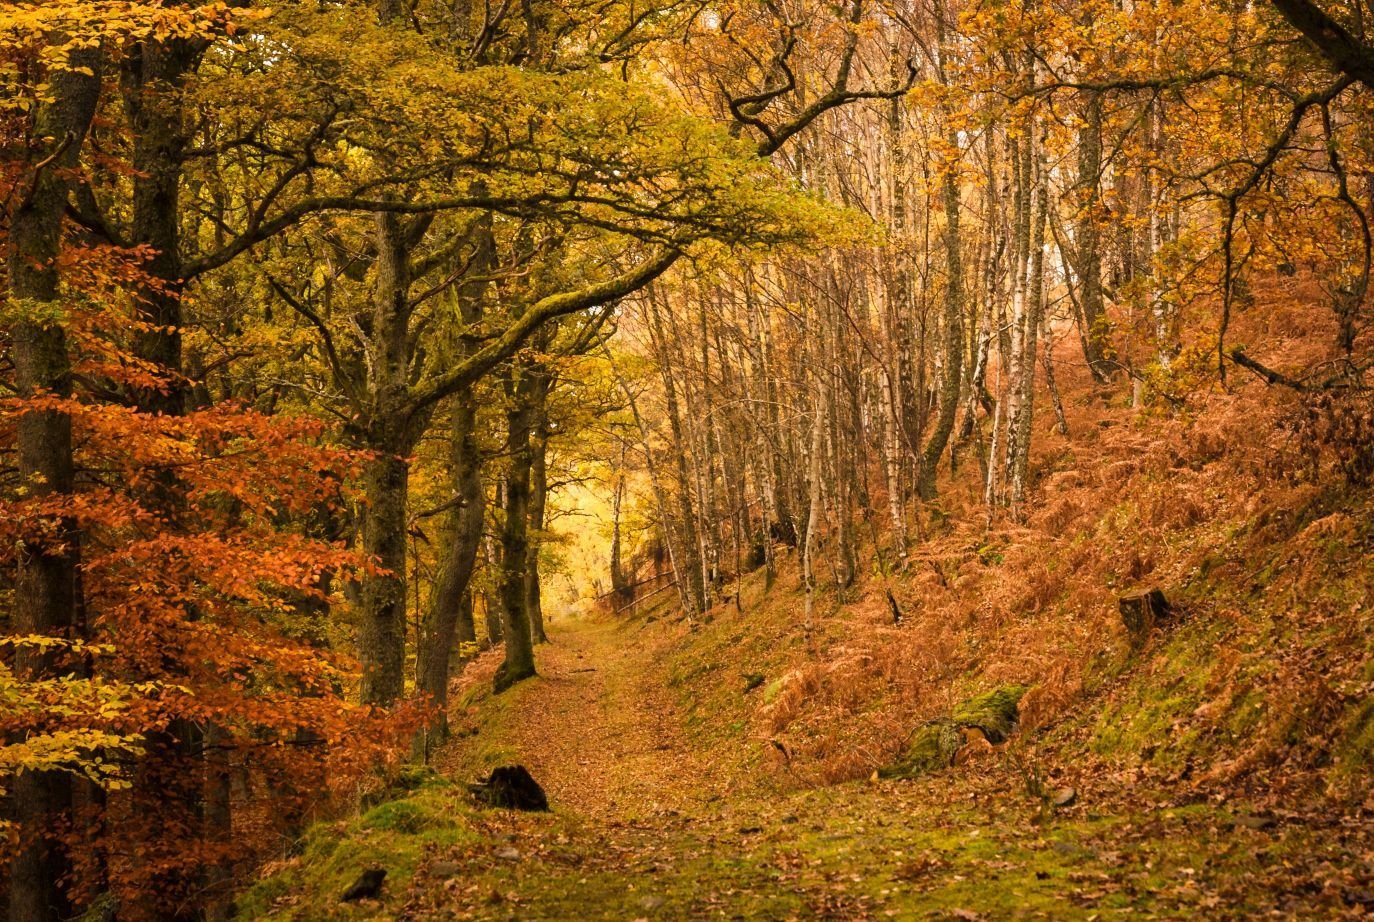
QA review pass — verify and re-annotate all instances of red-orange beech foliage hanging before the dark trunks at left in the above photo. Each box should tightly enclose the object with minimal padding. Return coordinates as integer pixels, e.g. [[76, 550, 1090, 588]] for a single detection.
[[0, 249, 418, 918]]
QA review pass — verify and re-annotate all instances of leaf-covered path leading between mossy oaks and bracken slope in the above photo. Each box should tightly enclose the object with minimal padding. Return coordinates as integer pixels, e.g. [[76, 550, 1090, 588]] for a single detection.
[[407, 618, 849, 919]]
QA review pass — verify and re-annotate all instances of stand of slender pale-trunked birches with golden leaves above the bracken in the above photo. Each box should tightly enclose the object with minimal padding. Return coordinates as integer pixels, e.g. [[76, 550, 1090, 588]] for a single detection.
[[623, 1, 1374, 611]]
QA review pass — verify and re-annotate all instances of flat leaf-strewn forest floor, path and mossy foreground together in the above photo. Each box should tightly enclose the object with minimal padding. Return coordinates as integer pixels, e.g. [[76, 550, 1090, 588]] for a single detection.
[[242, 618, 1374, 919]]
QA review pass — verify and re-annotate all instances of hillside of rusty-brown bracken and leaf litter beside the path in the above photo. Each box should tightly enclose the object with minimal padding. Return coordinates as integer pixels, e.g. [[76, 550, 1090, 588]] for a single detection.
[[659, 281, 1374, 798]]
